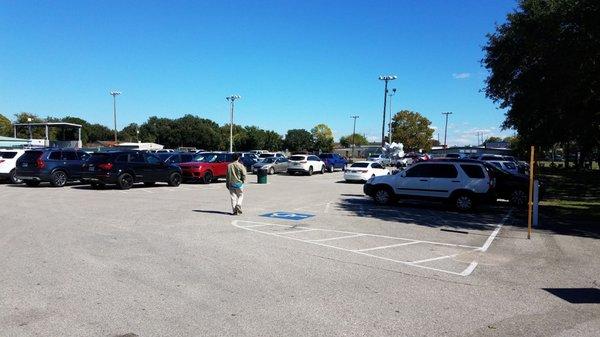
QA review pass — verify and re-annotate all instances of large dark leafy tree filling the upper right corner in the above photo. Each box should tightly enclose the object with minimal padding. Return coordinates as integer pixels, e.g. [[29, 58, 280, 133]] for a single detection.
[[482, 0, 600, 164]]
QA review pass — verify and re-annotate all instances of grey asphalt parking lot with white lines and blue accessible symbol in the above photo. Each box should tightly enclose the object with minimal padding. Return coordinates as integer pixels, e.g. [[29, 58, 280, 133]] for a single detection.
[[0, 172, 600, 336]]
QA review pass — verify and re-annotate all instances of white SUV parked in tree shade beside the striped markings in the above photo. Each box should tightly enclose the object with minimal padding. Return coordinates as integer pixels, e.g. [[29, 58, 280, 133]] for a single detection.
[[363, 160, 494, 211]]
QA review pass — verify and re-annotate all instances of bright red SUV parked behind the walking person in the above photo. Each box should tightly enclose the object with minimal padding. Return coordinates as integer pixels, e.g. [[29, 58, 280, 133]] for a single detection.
[[179, 152, 233, 184]]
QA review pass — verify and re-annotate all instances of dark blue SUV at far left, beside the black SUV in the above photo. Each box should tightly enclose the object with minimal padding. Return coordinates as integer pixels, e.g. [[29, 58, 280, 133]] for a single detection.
[[15, 148, 90, 187]]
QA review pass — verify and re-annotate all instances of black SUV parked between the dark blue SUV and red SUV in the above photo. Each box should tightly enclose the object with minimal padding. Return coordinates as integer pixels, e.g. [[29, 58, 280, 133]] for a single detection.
[[81, 151, 181, 190]]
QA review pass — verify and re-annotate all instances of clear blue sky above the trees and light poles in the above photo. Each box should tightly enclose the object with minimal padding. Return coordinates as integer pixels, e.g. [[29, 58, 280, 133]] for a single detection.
[[0, 0, 515, 144]]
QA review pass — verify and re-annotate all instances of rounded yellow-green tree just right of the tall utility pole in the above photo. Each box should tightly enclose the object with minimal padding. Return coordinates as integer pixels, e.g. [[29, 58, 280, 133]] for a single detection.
[[392, 110, 433, 151]]
